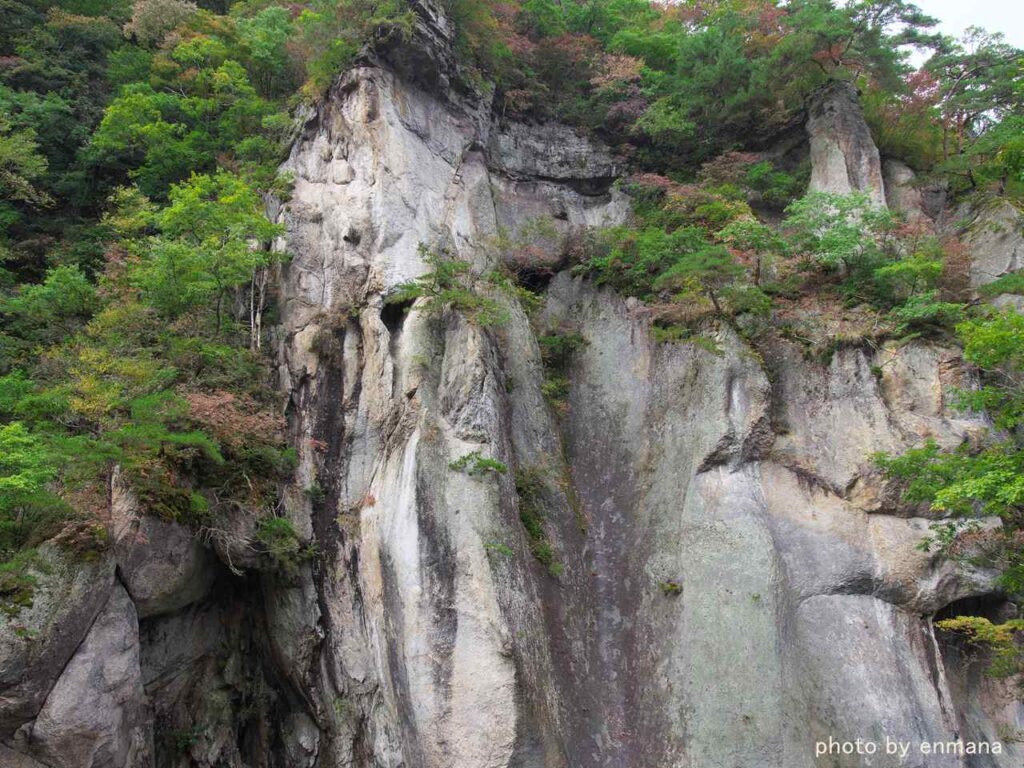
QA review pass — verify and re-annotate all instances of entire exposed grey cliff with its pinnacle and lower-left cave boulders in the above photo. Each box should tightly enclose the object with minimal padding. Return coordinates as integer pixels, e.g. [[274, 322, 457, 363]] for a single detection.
[[0, 3, 1024, 768]]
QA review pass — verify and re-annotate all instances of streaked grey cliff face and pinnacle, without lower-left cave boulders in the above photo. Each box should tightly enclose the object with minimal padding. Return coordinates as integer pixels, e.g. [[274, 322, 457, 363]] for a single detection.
[[260, 51, 1020, 768]]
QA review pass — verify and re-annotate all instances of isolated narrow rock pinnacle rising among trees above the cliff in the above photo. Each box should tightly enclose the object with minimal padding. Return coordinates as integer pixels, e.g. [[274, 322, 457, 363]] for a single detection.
[[807, 82, 886, 207]]
